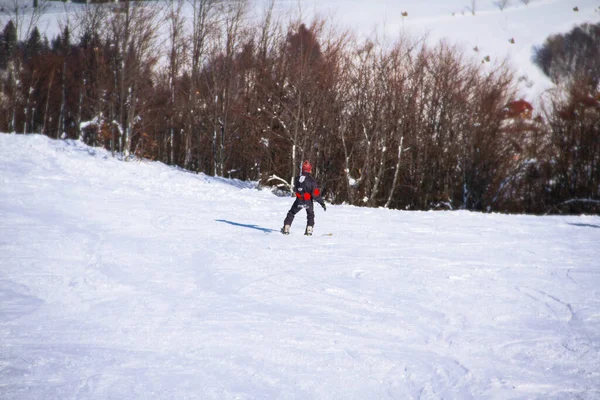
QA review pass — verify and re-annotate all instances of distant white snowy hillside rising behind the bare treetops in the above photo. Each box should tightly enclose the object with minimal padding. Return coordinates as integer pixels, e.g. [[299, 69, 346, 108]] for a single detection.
[[27, 0, 600, 103]]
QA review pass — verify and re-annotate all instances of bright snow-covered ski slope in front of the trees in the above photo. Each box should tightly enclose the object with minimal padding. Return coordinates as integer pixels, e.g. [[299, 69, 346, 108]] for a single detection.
[[0, 134, 600, 400]]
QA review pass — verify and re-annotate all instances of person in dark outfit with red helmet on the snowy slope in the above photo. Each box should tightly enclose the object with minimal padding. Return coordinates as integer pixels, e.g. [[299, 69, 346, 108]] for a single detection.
[[281, 160, 327, 236]]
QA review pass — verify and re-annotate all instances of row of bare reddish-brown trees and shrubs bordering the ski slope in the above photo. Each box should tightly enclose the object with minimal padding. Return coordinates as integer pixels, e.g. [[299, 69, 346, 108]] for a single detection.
[[0, 0, 600, 213]]
